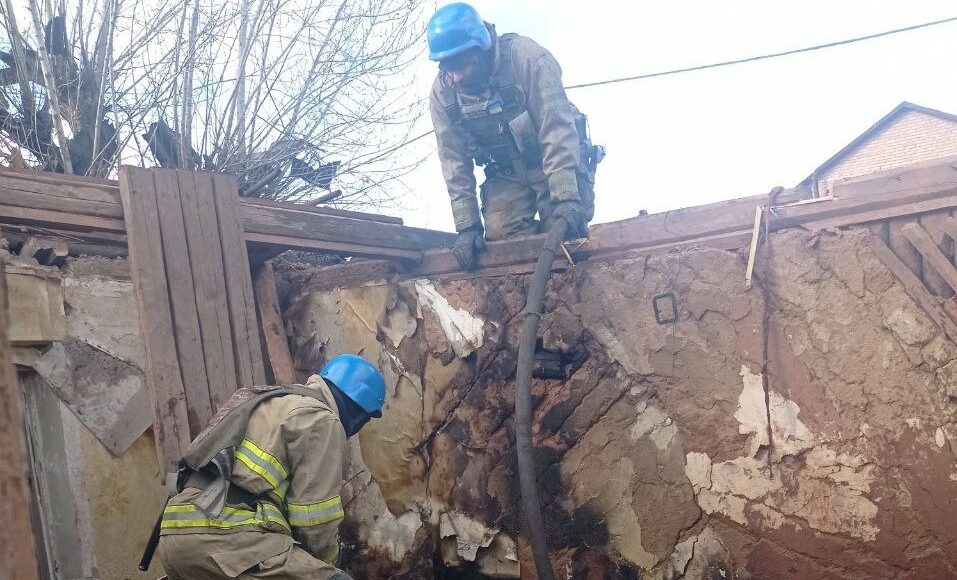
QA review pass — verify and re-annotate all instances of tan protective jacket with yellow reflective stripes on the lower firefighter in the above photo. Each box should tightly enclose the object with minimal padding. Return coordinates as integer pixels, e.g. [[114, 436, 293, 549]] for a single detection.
[[161, 375, 349, 563]]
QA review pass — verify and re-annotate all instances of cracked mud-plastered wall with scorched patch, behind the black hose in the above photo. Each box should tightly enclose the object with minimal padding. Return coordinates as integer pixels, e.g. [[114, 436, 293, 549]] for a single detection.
[[286, 229, 957, 580]]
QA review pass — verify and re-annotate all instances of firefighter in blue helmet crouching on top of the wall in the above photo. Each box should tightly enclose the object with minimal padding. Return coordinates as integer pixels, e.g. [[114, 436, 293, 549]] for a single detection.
[[427, 2, 604, 269]]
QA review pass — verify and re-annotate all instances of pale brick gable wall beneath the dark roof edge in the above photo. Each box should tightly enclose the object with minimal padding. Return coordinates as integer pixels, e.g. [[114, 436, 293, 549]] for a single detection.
[[818, 111, 957, 195]]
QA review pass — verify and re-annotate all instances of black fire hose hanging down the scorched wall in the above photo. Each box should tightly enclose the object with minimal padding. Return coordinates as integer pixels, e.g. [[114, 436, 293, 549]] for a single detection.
[[515, 218, 568, 580]]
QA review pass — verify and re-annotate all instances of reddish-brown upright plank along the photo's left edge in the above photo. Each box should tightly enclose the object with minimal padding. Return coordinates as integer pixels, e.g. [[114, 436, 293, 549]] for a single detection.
[[0, 260, 39, 580]]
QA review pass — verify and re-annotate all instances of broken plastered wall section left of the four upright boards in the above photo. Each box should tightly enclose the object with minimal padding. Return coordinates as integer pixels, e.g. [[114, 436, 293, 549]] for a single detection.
[[7, 256, 166, 580]]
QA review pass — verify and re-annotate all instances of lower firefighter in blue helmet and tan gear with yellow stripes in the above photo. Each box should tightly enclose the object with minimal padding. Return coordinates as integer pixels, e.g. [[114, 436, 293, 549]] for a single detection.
[[144, 354, 385, 580]]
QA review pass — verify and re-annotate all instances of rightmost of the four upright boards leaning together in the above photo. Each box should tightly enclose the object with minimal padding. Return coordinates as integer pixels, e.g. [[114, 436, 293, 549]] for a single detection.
[[210, 173, 266, 387]]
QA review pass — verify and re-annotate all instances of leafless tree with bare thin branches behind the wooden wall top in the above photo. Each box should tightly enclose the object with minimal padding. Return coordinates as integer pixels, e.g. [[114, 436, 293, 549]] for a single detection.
[[0, 0, 423, 204]]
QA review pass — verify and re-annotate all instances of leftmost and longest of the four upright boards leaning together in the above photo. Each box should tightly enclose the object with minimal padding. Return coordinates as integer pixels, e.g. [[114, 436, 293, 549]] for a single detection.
[[120, 167, 190, 470]]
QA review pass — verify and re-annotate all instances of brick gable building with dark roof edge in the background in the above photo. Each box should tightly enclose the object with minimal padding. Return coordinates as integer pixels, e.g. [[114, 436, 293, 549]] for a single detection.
[[799, 101, 957, 197]]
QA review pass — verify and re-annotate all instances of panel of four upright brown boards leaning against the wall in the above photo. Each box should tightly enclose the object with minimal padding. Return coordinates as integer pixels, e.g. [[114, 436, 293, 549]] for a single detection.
[[120, 167, 274, 465]]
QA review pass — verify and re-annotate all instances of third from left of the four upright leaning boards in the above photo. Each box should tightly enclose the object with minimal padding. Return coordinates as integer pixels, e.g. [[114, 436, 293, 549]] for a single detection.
[[175, 171, 236, 413]]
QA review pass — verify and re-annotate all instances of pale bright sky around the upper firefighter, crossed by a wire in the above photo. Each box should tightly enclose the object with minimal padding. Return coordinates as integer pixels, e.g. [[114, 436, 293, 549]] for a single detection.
[[393, 0, 957, 230]]
